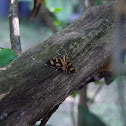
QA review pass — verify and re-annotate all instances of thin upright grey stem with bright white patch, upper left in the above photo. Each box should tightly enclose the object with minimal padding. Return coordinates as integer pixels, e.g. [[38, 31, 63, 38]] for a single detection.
[[8, 0, 22, 54]]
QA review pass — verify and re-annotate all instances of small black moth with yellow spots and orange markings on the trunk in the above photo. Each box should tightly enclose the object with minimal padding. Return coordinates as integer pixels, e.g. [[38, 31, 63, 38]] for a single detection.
[[45, 55, 75, 74]]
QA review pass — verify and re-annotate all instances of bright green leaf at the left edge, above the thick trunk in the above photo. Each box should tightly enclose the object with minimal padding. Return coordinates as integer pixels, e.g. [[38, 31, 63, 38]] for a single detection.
[[0, 48, 18, 66]]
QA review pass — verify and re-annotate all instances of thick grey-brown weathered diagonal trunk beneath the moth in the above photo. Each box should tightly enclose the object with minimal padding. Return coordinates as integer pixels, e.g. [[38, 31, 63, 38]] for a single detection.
[[0, 4, 123, 126]]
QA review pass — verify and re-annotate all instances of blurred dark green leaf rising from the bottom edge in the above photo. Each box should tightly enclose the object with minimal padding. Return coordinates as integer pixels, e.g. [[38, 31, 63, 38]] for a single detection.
[[78, 105, 106, 126]]
